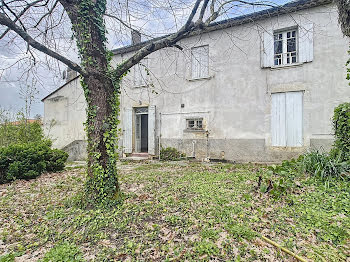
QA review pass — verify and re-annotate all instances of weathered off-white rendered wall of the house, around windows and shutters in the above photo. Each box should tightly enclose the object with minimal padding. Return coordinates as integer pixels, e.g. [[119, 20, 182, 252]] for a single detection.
[[45, 5, 350, 161]]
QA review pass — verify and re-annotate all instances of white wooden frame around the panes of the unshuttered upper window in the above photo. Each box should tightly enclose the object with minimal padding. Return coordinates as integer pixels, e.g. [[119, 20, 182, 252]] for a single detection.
[[273, 27, 300, 67]]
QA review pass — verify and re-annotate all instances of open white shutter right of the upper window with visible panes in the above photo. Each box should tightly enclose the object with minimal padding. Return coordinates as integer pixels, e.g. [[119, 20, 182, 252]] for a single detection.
[[299, 24, 314, 63]]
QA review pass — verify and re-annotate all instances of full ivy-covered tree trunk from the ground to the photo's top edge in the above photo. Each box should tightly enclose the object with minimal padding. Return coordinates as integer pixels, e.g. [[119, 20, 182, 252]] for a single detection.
[[60, 0, 120, 206]]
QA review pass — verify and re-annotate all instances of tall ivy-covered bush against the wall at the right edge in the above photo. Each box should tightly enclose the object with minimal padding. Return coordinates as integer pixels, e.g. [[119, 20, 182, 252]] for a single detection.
[[331, 103, 350, 160]]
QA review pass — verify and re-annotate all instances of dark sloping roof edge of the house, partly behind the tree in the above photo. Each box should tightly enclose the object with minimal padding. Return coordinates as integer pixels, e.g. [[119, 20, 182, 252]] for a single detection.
[[41, 0, 333, 102]]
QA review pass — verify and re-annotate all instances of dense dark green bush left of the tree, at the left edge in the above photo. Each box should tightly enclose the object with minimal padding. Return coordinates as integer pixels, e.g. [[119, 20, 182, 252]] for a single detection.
[[0, 141, 68, 184]]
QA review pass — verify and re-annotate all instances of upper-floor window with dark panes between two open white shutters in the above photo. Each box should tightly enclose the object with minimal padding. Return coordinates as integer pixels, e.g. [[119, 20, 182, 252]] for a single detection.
[[273, 29, 298, 66]]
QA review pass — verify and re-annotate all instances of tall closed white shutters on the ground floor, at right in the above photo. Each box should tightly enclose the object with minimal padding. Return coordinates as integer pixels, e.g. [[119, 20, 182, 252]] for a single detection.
[[271, 91, 303, 147]]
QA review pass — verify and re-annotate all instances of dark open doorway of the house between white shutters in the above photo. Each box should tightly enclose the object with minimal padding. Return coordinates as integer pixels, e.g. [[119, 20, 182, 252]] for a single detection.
[[135, 107, 148, 153]]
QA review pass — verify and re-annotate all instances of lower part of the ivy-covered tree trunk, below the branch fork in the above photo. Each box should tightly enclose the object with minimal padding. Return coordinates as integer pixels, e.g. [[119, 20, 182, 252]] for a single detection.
[[83, 73, 120, 205]]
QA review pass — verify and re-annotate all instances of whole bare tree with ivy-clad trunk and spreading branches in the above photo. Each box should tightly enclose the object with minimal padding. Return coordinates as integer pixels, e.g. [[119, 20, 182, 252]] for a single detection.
[[0, 0, 269, 205]]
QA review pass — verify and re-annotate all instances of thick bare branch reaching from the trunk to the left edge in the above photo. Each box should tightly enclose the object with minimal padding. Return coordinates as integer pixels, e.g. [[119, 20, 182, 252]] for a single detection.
[[0, 13, 86, 75]]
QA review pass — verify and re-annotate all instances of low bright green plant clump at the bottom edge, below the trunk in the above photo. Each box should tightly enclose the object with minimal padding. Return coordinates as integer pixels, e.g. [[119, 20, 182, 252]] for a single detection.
[[42, 242, 85, 262]]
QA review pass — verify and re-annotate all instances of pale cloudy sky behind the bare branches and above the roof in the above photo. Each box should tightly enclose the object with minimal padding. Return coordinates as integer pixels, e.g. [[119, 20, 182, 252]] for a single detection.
[[0, 0, 288, 117]]
